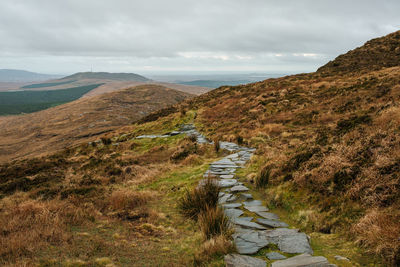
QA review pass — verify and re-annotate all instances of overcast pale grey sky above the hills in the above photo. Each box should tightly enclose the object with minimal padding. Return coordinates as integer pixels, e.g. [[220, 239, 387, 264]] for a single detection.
[[0, 0, 400, 74]]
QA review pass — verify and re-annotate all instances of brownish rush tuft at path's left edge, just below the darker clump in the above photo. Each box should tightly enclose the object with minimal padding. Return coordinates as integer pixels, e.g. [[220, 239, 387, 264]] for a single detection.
[[198, 206, 231, 239]]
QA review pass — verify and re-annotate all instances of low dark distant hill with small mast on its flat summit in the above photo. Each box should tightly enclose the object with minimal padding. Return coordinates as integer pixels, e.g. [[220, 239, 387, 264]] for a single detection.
[[61, 72, 150, 82]]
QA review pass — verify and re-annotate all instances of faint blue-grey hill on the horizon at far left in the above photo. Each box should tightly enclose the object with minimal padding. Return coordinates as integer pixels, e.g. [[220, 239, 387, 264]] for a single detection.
[[0, 69, 61, 82]]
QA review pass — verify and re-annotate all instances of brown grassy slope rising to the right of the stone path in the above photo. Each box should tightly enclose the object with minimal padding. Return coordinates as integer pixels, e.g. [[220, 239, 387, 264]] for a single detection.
[[143, 32, 400, 266]]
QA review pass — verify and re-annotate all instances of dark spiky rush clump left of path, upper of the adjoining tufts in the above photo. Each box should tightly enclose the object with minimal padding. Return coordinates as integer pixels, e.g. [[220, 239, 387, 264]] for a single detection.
[[178, 178, 220, 219]]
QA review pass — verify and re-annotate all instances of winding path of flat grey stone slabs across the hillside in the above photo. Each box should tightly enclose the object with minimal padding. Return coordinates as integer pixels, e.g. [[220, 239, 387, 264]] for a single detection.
[[136, 124, 336, 267]]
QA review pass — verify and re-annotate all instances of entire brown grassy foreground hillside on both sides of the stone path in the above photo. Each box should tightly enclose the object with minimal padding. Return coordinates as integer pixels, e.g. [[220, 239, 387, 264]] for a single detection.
[[0, 30, 400, 266]]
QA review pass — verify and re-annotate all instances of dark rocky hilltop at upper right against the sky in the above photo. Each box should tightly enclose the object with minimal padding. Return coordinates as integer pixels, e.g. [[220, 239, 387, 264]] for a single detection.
[[317, 31, 400, 74]]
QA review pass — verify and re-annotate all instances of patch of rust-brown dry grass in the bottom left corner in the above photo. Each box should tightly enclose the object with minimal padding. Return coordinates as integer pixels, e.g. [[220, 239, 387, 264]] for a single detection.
[[0, 195, 95, 264]]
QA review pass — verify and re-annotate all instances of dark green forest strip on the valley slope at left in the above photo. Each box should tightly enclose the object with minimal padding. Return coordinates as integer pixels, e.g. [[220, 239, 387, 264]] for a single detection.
[[0, 84, 102, 116]]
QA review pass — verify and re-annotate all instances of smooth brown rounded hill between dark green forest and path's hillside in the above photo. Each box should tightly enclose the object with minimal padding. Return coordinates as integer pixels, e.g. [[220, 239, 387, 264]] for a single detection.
[[0, 85, 191, 161]]
